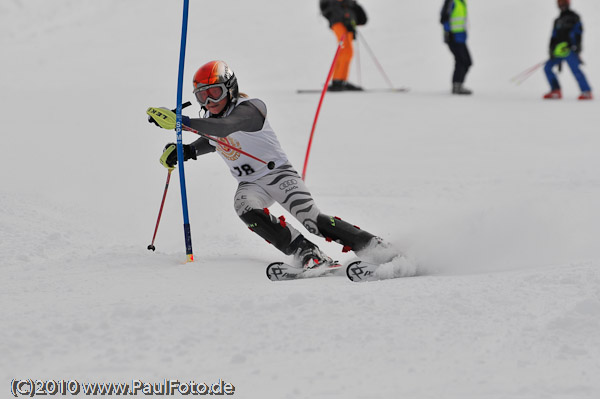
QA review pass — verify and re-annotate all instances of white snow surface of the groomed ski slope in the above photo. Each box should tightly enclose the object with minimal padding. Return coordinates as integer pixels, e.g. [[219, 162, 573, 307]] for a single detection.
[[0, 0, 600, 399]]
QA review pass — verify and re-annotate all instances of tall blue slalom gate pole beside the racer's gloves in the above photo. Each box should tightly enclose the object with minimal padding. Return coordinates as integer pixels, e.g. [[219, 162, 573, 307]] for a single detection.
[[175, 0, 194, 262]]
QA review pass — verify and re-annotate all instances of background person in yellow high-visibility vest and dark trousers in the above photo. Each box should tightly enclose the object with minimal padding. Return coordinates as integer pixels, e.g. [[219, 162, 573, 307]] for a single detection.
[[440, 0, 473, 95]]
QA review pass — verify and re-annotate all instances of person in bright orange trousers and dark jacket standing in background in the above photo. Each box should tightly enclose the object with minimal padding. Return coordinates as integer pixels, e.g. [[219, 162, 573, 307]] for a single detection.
[[319, 0, 367, 91]]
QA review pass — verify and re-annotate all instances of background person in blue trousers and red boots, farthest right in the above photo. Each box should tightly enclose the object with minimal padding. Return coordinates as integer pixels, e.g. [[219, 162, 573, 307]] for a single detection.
[[544, 0, 592, 100]]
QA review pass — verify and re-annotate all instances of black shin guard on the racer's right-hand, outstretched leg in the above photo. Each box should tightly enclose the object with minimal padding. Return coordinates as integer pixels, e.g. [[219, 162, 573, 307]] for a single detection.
[[317, 213, 375, 252]]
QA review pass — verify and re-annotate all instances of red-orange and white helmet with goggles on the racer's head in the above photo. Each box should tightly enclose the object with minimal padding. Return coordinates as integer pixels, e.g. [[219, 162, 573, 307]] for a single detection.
[[194, 61, 239, 106]]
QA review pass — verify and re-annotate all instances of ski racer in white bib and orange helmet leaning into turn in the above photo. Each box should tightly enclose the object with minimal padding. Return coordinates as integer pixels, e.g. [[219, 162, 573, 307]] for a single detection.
[[147, 61, 398, 268]]
